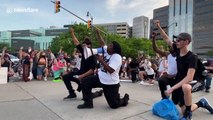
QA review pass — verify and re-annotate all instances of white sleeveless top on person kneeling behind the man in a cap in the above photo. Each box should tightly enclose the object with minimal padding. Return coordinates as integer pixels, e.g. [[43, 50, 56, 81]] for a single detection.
[[167, 54, 177, 75]]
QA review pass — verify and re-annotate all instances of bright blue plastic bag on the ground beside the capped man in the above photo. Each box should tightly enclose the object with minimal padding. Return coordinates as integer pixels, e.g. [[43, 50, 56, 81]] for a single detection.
[[152, 99, 179, 120]]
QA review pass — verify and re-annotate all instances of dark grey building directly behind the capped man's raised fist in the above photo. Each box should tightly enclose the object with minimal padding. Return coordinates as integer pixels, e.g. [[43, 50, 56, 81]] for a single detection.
[[150, 5, 170, 39]]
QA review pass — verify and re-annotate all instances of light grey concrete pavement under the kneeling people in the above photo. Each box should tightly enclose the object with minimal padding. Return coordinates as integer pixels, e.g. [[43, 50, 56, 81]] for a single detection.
[[0, 80, 213, 120]]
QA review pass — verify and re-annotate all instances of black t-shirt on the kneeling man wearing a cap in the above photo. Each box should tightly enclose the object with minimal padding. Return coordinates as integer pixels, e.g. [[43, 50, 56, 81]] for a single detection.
[[174, 43, 203, 82]]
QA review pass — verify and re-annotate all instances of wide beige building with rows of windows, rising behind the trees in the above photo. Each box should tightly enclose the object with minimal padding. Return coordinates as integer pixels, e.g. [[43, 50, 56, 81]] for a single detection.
[[95, 22, 129, 38]]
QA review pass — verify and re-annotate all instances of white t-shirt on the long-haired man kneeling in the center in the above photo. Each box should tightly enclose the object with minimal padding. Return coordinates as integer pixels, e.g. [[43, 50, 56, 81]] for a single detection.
[[98, 53, 122, 85]]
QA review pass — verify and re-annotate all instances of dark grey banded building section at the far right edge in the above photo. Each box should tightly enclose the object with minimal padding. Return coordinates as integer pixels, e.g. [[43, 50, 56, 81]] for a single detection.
[[193, 0, 213, 57]]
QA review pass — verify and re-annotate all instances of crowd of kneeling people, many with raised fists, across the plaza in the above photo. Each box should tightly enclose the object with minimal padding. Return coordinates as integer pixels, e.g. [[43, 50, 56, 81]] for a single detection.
[[1, 20, 213, 120]]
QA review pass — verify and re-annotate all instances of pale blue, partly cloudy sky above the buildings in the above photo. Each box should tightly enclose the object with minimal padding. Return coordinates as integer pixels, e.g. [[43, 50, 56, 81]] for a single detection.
[[0, 0, 168, 31]]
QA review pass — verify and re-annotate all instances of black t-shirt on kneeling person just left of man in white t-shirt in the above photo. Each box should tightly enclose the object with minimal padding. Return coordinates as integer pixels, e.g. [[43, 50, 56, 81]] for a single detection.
[[76, 44, 97, 73]]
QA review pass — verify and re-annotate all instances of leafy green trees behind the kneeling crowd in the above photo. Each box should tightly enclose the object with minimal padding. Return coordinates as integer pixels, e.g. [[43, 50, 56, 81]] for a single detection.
[[50, 23, 166, 58]]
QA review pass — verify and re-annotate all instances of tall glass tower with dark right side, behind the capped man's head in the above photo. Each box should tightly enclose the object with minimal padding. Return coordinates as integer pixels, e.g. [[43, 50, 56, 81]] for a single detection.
[[169, 0, 213, 57]]
